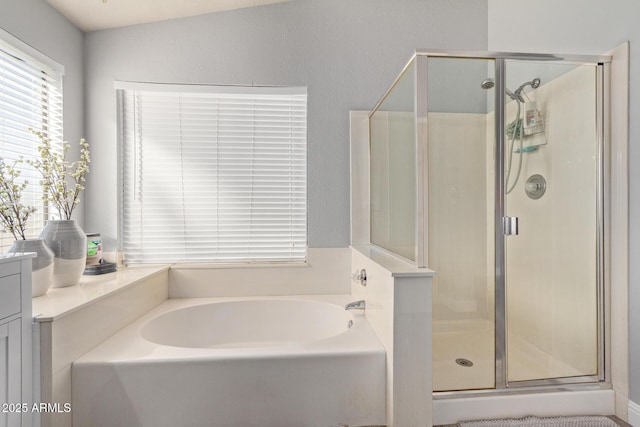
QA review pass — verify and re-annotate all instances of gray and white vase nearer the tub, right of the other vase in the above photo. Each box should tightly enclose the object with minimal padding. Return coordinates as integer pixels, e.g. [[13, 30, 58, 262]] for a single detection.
[[40, 219, 87, 288]]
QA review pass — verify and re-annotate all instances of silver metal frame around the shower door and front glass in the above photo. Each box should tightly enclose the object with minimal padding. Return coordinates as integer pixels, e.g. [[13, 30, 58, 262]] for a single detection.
[[410, 50, 611, 396]]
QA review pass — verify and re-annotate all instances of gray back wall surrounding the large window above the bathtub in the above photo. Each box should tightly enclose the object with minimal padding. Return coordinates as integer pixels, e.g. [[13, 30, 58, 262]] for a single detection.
[[85, 0, 487, 250]]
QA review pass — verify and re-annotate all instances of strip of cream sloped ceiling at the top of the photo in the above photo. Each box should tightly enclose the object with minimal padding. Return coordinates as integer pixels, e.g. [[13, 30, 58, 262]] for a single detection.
[[47, 0, 291, 31]]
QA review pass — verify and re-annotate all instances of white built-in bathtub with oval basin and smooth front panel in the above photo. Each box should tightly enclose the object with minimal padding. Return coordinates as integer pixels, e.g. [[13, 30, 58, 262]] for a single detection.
[[72, 295, 386, 427]]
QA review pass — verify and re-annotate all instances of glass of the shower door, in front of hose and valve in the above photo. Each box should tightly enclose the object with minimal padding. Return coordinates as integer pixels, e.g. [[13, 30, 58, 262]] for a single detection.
[[505, 61, 600, 383]]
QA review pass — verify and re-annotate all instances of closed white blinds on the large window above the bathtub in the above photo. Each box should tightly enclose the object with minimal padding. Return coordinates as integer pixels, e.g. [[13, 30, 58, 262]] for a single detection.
[[116, 82, 307, 264]]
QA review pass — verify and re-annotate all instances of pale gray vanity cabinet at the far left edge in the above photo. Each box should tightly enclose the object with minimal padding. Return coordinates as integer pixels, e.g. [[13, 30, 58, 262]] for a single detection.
[[0, 254, 35, 427]]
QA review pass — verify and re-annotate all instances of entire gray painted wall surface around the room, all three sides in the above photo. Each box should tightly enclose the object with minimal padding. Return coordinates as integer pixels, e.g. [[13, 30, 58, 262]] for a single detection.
[[0, 0, 640, 403]]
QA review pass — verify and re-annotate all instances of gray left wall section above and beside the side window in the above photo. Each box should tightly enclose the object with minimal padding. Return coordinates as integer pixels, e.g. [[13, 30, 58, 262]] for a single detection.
[[0, 0, 84, 224]]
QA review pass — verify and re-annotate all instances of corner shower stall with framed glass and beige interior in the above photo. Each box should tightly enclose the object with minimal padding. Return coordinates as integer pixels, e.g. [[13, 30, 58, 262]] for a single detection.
[[369, 51, 610, 399]]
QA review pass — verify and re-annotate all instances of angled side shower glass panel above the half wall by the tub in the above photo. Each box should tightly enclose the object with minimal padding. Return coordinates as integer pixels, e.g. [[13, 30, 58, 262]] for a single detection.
[[369, 61, 417, 261]]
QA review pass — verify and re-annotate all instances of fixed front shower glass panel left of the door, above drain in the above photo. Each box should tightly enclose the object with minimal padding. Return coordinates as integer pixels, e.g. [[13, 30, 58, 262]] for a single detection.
[[428, 57, 495, 391]]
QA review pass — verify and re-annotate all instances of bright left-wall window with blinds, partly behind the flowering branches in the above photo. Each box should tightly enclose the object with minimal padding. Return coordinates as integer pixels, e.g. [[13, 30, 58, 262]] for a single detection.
[[0, 30, 63, 252]]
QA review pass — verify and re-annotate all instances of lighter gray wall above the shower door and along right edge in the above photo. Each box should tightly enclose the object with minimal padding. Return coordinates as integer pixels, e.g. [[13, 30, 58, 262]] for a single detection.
[[488, 0, 640, 403]]
